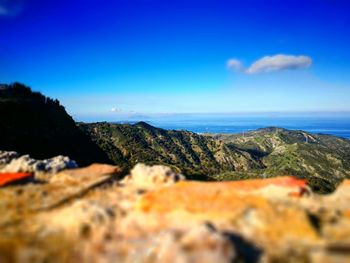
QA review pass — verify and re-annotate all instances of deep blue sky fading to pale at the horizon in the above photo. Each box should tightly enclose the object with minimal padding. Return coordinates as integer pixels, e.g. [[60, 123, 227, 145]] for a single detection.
[[0, 0, 350, 120]]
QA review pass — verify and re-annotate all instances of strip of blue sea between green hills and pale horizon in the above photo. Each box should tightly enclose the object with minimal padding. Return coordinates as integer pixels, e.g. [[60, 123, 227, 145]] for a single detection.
[[116, 113, 350, 139]]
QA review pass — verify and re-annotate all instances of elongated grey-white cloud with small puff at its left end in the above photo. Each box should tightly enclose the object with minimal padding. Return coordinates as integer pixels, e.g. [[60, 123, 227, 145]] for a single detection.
[[227, 54, 312, 74]]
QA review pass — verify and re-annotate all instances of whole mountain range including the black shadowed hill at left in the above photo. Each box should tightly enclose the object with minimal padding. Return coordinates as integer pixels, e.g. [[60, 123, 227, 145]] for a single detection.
[[0, 83, 350, 192]]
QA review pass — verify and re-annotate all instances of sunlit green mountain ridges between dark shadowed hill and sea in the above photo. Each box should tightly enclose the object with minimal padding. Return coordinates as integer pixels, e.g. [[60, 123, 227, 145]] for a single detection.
[[79, 122, 350, 192]]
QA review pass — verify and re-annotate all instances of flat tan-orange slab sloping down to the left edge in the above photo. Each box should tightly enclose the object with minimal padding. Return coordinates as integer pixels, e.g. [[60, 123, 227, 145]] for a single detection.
[[0, 164, 120, 227]]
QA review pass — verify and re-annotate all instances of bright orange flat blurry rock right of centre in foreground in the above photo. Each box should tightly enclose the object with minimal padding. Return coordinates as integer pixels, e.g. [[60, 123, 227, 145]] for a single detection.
[[137, 179, 317, 245]]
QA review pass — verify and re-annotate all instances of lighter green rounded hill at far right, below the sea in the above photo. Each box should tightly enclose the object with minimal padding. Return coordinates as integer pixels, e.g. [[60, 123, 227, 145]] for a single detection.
[[212, 127, 350, 194]]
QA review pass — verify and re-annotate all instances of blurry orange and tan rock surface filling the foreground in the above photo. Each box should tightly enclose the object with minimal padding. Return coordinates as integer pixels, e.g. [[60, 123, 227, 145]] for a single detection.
[[0, 164, 350, 263]]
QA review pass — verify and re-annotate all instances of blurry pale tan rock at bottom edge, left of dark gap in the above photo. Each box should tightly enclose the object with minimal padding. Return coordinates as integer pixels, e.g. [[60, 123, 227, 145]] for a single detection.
[[83, 224, 236, 263]]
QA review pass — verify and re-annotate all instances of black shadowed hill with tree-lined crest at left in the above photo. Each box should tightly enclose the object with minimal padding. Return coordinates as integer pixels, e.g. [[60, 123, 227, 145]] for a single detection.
[[0, 83, 110, 165]]
